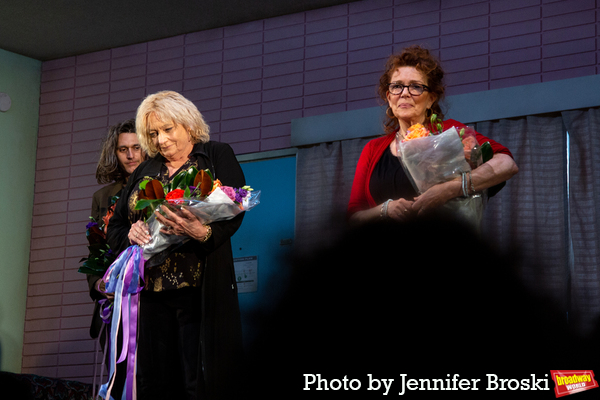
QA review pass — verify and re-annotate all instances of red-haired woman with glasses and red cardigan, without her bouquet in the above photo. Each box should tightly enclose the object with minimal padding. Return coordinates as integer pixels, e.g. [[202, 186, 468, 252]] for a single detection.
[[348, 46, 518, 223]]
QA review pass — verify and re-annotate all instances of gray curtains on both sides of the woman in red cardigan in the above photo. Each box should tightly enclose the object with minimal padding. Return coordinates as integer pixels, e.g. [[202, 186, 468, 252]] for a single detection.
[[296, 109, 600, 334]]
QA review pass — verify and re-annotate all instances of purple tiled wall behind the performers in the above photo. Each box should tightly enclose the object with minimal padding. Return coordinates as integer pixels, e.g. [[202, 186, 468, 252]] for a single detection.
[[23, 0, 600, 381]]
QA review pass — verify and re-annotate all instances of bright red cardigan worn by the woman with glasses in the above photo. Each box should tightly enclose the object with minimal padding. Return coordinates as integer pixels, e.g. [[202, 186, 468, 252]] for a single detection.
[[348, 119, 512, 216]]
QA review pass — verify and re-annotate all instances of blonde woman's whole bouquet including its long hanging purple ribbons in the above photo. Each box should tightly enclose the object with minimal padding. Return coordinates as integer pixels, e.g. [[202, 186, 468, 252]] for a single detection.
[[99, 167, 260, 400]]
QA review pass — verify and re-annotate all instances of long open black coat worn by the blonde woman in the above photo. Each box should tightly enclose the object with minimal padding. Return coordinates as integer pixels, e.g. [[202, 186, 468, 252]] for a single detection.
[[107, 141, 246, 399]]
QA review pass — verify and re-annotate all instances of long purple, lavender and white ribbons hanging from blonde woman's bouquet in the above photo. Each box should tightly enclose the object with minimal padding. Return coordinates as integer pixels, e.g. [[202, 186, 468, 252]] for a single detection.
[[98, 246, 144, 400]]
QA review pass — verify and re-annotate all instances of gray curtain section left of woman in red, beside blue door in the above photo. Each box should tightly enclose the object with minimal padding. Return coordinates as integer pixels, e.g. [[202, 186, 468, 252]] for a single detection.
[[294, 139, 370, 252]]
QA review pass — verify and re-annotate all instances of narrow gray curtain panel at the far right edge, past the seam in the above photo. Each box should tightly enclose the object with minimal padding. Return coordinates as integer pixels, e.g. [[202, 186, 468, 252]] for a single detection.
[[562, 108, 600, 334]]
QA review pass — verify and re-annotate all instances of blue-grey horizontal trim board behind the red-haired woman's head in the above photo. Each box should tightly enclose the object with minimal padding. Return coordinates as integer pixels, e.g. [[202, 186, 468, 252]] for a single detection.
[[291, 75, 600, 147]]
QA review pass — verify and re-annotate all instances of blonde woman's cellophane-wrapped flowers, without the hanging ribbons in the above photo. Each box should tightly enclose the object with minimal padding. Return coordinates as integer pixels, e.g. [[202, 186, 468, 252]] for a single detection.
[[135, 167, 260, 260]]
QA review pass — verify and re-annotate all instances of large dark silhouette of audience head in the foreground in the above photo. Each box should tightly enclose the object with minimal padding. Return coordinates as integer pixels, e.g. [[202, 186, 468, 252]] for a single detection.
[[244, 215, 600, 399]]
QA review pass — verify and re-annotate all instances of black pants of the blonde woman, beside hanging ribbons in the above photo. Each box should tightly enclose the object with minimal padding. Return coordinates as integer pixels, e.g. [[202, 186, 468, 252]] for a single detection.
[[137, 288, 202, 400]]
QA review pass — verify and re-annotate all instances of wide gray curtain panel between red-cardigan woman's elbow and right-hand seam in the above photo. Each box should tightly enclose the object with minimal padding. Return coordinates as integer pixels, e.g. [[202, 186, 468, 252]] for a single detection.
[[476, 114, 569, 318]]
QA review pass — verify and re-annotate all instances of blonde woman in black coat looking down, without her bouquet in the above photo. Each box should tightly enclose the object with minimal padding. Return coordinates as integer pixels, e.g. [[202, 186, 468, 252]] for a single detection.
[[108, 91, 245, 399]]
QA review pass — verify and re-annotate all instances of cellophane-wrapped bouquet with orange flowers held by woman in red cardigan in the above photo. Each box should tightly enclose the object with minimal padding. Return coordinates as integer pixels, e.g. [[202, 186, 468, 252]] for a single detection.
[[397, 114, 493, 227]]
